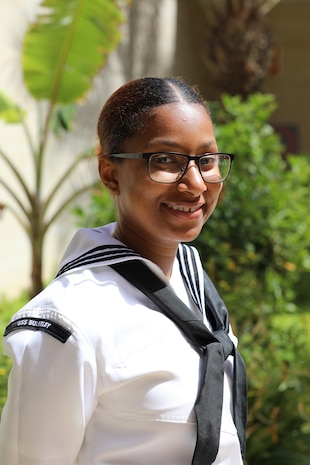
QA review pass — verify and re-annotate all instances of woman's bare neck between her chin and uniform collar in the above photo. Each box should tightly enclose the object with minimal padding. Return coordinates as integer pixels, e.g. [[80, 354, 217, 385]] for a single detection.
[[113, 225, 178, 279]]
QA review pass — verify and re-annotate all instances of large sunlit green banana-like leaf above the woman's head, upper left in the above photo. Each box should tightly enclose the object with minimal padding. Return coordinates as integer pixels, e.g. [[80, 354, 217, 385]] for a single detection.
[[22, 0, 123, 104]]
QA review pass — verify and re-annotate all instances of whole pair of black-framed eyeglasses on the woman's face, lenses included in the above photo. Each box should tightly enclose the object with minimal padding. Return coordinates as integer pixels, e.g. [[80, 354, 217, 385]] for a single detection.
[[110, 152, 235, 184]]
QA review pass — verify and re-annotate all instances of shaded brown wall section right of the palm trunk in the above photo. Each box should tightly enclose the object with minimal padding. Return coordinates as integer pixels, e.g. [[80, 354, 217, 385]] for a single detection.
[[265, 0, 310, 153]]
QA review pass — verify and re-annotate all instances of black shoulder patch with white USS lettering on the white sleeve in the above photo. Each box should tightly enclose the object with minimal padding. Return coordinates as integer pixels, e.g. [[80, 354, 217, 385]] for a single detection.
[[4, 317, 71, 343]]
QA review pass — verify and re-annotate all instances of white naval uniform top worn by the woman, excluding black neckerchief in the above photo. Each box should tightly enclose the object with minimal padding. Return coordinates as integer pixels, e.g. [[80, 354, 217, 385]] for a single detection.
[[0, 224, 242, 465]]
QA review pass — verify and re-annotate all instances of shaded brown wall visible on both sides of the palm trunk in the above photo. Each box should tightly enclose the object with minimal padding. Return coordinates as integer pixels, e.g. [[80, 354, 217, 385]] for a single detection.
[[175, 0, 310, 153]]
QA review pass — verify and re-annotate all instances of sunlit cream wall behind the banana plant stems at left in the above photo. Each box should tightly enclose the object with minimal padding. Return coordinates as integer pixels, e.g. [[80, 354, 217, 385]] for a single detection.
[[0, 0, 176, 300]]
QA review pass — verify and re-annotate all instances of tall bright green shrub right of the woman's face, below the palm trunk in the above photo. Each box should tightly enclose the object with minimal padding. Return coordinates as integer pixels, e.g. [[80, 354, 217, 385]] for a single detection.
[[196, 94, 310, 320]]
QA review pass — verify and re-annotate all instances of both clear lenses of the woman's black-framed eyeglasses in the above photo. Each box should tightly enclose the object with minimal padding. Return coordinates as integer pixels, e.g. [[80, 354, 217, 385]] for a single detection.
[[149, 153, 230, 183]]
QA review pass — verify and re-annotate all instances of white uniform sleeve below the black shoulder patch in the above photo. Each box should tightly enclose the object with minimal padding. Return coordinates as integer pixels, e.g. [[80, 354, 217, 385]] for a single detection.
[[0, 320, 97, 465]]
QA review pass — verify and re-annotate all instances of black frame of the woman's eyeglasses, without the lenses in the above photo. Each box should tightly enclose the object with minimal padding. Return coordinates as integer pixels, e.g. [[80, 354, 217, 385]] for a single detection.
[[109, 150, 235, 184]]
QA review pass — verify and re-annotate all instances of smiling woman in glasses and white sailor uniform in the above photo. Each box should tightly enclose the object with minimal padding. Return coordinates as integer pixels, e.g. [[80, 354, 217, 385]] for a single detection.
[[0, 78, 245, 465]]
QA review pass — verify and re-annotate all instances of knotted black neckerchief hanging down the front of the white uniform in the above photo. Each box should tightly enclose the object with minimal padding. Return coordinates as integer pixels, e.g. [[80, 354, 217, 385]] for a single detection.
[[110, 260, 247, 465]]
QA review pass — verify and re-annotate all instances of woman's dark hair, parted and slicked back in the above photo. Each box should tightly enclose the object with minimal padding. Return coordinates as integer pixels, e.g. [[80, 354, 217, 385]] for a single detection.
[[97, 77, 210, 155]]
